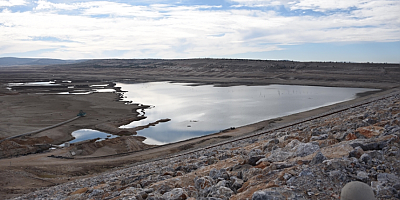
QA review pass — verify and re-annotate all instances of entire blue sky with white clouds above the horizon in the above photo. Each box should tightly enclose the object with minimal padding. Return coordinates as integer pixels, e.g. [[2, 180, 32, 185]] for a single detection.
[[0, 0, 400, 63]]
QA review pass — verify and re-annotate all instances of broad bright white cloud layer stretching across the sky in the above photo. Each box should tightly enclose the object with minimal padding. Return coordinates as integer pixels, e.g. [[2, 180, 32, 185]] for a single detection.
[[0, 0, 400, 58]]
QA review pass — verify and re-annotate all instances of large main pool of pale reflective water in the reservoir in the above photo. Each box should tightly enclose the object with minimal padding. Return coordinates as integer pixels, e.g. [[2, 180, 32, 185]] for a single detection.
[[116, 82, 373, 143]]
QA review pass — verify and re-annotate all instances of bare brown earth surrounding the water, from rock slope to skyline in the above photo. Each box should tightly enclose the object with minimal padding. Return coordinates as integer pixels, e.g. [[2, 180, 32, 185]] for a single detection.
[[0, 59, 400, 198]]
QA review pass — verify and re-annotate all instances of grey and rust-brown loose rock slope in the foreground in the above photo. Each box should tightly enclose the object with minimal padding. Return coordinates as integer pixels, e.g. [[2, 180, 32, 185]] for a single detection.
[[12, 95, 400, 200]]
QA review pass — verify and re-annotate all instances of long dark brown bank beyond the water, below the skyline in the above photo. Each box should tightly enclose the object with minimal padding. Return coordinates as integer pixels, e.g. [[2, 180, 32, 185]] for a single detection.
[[0, 59, 400, 88]]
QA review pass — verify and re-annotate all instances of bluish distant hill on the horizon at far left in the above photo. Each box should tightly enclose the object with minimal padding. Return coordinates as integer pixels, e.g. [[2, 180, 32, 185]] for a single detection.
[[0, 57, 85, 67]]
